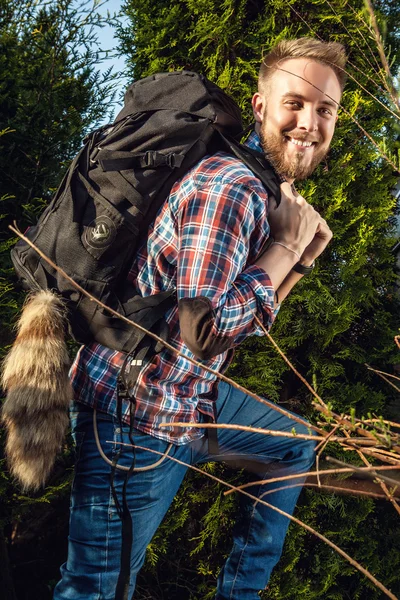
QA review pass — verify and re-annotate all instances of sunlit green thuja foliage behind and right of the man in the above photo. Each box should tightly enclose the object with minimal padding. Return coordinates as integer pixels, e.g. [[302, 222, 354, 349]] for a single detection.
[[120, 0, 400, 600]]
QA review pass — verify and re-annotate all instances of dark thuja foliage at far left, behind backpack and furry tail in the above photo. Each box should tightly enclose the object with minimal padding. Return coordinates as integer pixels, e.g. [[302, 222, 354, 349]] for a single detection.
[[0, 0, 119, 600]]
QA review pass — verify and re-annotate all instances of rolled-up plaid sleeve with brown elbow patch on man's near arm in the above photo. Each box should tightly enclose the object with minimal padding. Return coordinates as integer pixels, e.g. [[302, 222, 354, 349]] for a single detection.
[[177, 176, 277, 359]]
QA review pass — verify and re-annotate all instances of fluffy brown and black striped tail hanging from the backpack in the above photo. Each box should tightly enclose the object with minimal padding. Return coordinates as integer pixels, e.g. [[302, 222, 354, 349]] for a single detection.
[[1, 291, 72, 490]]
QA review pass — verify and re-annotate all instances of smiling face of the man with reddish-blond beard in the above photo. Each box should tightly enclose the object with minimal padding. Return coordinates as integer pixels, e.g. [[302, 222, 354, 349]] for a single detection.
[[253, 58, 341, 182]]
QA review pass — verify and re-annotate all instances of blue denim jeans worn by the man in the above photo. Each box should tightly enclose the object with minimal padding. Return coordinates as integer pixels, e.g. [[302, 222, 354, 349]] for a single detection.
[[54, 382, 315, 600]]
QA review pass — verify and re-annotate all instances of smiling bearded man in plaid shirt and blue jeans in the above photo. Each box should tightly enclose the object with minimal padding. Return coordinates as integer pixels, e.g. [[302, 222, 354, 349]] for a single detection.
[[54, 38, 345, 600]]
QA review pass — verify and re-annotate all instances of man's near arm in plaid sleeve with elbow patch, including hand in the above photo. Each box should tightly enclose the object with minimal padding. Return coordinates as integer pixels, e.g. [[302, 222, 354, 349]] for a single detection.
[[177, 176, 332, 360]]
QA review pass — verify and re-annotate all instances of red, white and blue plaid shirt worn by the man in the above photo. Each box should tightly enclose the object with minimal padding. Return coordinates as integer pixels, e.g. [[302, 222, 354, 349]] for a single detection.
[[71, 133, 278, 444]]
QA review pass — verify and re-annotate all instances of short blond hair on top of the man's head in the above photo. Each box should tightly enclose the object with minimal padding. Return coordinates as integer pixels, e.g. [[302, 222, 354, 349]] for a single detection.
[[258, 37, 347, 91]]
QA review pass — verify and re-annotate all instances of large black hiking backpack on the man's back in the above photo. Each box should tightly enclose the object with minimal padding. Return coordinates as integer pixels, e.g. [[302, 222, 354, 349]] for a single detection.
[[11, 71, 280, 366]]
